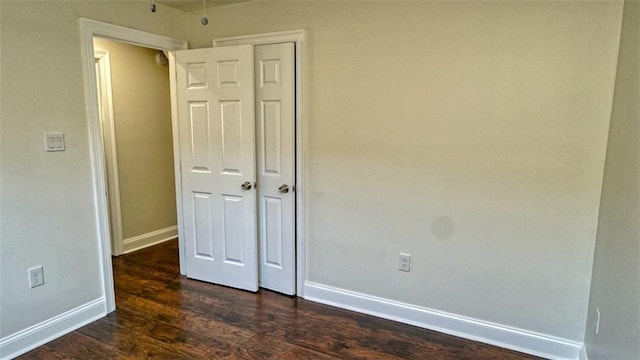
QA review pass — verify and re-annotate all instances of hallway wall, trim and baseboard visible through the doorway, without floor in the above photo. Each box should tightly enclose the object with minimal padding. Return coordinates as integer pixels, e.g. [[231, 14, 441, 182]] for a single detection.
[[93, 38, 178, 256]]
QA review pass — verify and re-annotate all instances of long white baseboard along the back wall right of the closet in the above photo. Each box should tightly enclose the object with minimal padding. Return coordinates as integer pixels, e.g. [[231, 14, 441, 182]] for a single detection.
[[304, 282, 582, 360]]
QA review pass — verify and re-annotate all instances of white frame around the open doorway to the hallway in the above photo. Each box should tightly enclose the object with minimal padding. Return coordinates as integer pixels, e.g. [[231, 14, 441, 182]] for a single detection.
[[80, 18, 187, 313]]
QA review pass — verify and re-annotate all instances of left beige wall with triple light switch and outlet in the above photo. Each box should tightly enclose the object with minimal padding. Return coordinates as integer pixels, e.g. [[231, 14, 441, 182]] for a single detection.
[[0, 0, 186, 338]]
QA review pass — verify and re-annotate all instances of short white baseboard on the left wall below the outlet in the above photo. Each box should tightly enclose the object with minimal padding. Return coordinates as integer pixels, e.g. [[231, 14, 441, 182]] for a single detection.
[[0, 298, 107, 360]]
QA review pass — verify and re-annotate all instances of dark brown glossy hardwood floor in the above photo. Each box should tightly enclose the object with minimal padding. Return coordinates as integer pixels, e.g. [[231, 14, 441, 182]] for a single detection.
[[19, 241, 536, 359]]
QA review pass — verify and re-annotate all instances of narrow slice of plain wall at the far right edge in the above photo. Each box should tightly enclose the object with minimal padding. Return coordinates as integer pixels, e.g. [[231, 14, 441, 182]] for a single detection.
[[585, 1, 640, 360]]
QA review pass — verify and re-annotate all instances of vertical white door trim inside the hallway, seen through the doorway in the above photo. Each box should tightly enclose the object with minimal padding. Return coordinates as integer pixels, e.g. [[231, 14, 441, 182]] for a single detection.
[[94, 50, 124, 255]]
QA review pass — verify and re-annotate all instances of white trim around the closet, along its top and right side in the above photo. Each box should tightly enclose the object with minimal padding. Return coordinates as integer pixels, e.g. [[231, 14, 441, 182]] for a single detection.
[[213, 29, 308, 297]]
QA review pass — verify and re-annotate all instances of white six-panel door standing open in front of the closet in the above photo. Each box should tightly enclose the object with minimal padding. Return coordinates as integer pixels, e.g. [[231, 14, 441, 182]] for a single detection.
[[176, 45, 258, 291]]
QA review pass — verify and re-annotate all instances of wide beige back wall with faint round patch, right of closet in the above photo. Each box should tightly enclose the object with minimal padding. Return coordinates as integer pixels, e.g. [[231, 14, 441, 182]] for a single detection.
[[187, 1, 622, 342]]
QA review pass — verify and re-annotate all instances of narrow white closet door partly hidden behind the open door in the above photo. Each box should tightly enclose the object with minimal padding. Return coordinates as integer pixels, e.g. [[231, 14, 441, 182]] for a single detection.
[[255, 43, 296, 295]]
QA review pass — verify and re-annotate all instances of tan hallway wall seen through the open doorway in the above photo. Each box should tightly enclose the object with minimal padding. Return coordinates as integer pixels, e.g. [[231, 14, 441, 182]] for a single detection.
[[94, 39, 177, 239]]
